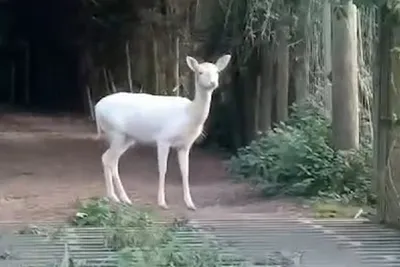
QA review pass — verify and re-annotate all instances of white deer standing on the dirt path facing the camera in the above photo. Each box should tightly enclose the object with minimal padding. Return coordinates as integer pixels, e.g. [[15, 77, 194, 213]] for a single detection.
[[95, 55, 231, 210]]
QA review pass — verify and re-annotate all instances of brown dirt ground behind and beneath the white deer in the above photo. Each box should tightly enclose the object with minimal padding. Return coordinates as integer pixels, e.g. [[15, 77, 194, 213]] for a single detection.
[[0, 113, 310, 222]]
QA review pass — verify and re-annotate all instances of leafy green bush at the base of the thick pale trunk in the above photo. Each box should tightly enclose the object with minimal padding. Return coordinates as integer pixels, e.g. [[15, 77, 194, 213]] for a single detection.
[[228, 102, 374, 204]]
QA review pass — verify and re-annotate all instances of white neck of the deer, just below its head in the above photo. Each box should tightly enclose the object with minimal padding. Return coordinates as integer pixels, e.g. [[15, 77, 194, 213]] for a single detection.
[[189, 81, 212, 126]]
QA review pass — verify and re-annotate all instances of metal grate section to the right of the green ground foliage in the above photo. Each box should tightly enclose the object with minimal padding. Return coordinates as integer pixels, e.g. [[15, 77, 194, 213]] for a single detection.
[[191, 219, 400, 267]]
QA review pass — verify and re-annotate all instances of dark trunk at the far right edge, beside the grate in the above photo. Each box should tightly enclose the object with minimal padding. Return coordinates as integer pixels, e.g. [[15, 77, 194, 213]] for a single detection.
[[373, 4, 400, 227]]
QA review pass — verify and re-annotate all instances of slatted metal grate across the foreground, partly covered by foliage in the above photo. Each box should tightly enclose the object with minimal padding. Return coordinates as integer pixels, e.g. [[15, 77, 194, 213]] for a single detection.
[[0, 219, 400, 267]]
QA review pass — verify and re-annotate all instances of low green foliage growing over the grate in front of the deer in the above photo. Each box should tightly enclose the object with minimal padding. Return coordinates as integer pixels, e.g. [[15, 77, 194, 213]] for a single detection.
[[73, 199, 245, 267]]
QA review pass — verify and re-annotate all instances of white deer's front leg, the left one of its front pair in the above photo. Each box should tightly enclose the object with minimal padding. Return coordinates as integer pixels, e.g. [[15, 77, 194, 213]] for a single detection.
[[157, 143, 170, 209]]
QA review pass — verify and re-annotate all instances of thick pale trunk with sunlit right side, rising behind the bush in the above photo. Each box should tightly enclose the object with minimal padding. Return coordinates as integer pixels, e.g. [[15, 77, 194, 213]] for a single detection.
[[332, 1, 359, 150]]
